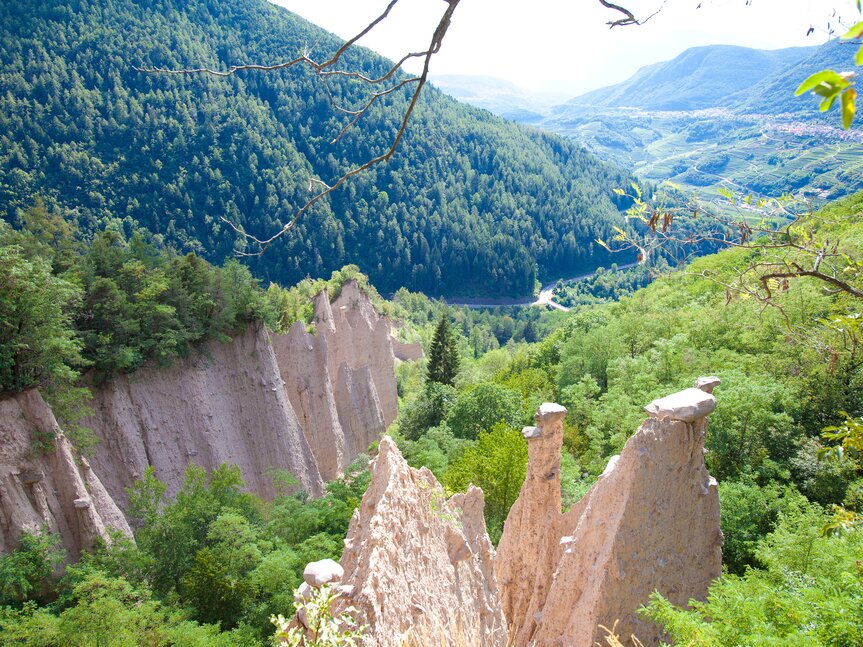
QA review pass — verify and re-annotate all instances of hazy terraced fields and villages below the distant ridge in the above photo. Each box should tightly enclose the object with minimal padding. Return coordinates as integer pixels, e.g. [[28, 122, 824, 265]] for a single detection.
[[543, 108, 863, 210]]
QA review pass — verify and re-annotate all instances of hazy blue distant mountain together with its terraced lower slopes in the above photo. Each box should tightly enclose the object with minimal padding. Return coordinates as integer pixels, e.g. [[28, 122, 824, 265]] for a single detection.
[[538, 41, 863, 204]]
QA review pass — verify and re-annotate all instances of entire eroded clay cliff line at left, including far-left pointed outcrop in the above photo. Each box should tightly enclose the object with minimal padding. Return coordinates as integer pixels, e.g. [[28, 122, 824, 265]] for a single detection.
[[0, 281, 408, 558]]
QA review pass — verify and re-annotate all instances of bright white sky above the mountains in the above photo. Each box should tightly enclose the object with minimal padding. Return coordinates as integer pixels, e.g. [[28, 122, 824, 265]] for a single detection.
[[270, 0, 859, 96]]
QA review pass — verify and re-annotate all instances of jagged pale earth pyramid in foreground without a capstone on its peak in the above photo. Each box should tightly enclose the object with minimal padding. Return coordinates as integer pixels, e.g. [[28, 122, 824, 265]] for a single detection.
[[330, 436, 507, 647]]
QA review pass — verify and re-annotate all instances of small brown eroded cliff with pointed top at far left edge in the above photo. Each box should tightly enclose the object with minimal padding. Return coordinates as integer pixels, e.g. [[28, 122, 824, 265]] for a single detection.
[[0, 389, 132, 559]]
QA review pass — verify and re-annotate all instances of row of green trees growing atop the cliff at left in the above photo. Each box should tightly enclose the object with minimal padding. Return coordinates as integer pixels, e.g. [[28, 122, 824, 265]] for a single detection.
[[0, 202, 273, 392]]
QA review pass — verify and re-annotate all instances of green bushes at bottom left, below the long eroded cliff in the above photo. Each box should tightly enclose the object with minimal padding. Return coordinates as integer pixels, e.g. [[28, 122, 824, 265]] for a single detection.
[[0, 457, 369, 646]]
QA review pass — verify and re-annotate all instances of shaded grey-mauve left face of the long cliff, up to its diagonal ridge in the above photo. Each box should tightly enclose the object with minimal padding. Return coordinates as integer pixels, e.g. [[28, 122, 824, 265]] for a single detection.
[[83, 327, 323, 506]]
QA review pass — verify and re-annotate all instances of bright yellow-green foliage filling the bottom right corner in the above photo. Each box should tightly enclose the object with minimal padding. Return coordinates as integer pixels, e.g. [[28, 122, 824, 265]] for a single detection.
[[642, 503, 863, 647]]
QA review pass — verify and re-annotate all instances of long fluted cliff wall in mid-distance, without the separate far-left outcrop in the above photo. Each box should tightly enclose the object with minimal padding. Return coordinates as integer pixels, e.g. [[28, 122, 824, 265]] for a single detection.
[[83, 282, 398, 506]]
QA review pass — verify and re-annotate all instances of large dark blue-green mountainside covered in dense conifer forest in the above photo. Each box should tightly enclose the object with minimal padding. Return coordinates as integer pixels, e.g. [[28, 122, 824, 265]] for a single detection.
[[0, 0, 627, 295]]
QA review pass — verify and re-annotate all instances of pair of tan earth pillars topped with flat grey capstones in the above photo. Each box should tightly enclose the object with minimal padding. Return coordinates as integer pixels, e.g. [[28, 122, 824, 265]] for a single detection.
[[495, 381, 722, 647]]
